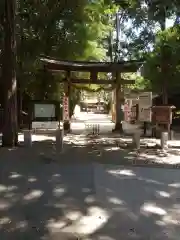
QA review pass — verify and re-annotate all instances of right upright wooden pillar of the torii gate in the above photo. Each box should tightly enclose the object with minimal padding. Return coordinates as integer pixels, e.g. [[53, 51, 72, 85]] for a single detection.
[[113, 73, 124, 133]]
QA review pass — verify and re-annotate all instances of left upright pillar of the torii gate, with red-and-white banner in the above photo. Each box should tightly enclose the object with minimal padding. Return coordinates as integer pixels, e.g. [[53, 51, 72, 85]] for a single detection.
[[63, 79, 71, 132]]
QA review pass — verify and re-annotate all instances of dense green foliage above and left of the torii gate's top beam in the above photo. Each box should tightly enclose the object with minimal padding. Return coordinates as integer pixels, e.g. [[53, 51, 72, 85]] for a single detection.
[[13, 0, 114, 99]]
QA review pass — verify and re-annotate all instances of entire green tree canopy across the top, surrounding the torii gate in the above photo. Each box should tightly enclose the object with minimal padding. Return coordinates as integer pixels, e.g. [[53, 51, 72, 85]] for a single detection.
[[0, 0, 180, 101]]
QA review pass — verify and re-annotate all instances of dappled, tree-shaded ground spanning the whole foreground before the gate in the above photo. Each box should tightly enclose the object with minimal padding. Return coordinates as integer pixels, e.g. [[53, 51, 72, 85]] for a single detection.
[[0, 134, 180, 240]]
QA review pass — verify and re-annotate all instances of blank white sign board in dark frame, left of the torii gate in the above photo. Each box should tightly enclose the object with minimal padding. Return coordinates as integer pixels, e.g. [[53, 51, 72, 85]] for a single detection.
[[34, 104, 56, 118]]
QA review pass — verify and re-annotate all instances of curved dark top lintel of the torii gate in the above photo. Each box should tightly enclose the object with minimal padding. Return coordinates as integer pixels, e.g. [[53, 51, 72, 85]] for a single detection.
[[40, 57, 144, 72]]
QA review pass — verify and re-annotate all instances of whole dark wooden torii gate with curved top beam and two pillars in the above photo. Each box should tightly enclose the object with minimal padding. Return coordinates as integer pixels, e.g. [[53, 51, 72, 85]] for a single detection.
[[41, 56, 143, 131]]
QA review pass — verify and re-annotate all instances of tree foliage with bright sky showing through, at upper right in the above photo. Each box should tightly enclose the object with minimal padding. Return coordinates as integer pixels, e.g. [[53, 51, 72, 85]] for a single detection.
[[116, 0, 180, 59]]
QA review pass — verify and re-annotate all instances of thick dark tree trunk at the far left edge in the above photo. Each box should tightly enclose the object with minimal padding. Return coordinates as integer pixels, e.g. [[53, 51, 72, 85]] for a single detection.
[[2, 0, 18, 147]]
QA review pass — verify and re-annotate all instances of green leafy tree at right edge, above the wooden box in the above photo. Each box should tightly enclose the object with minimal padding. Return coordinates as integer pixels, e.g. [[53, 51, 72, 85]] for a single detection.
[[144, 25, 180, 91]]
